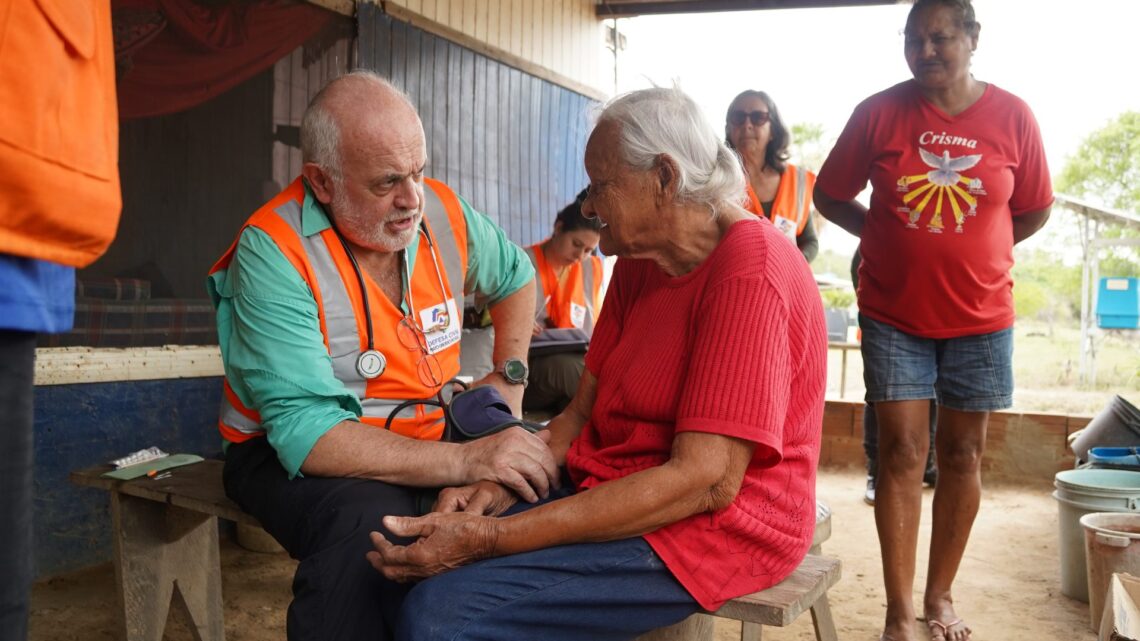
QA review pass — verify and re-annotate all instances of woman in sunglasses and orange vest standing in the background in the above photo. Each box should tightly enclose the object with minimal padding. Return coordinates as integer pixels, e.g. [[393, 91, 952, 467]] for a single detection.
[[724, 89, 820, 262]]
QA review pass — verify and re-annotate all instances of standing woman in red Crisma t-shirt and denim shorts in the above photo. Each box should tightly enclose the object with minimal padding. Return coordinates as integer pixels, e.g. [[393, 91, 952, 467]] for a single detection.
[[815, 0, 1053, 641]]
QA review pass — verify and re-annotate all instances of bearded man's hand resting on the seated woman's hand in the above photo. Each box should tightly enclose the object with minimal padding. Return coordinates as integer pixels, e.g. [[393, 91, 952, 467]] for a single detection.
[[462, 425, 559, 503]]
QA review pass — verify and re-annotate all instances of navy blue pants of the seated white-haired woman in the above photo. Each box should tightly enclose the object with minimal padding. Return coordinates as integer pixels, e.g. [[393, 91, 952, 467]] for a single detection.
[[396, 537, 699, 641]]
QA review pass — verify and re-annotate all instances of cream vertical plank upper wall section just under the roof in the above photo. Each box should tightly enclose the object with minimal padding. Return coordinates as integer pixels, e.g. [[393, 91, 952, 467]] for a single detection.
[[386, 0, 612, 90]]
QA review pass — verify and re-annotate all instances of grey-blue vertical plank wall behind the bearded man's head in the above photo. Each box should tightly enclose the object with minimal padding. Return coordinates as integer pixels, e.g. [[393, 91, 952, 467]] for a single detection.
[[357, 5, 596, 245]]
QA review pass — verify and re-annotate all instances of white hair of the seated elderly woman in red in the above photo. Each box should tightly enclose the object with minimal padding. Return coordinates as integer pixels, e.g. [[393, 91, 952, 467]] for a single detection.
[[597, 87, 744, 217]]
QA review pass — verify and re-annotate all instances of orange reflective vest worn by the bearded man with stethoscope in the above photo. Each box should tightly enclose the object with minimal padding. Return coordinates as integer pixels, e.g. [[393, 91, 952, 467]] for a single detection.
[[211, 178, 467, 443]]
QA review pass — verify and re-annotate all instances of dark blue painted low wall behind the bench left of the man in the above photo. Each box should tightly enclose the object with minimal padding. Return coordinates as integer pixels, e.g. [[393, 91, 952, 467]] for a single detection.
[[35, 378, 221, 576]]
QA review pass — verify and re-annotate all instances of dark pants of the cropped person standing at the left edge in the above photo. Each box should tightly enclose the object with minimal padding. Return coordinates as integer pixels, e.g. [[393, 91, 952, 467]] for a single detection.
[[0, 330, 35, 641]]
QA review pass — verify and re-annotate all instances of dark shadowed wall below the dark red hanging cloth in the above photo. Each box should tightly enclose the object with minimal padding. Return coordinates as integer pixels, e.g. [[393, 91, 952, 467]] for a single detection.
[[88, 71, 272, 299]]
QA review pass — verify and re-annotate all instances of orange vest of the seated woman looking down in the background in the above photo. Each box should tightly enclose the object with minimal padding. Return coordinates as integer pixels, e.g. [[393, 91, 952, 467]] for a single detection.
[[527, 241, 602, 334]]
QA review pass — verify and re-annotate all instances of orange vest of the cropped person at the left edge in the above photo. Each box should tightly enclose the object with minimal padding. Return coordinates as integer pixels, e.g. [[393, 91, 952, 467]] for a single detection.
[[0, 0, 122, 267]]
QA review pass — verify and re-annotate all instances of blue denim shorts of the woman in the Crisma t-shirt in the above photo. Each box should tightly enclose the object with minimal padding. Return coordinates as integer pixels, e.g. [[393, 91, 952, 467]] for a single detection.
[[860, 314, 1013, 412]]
